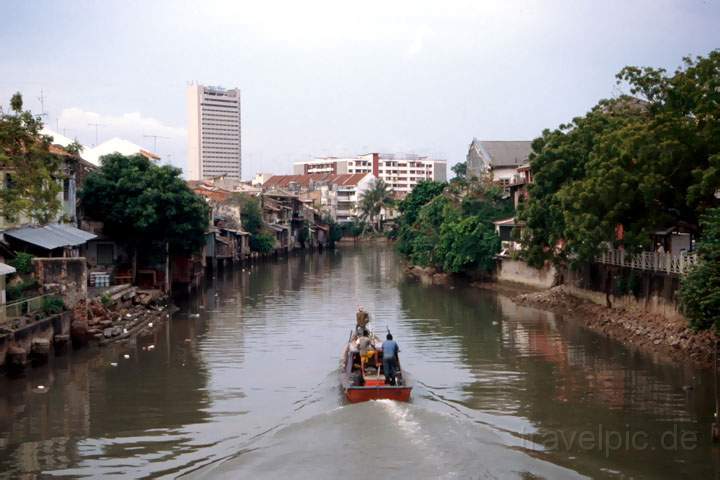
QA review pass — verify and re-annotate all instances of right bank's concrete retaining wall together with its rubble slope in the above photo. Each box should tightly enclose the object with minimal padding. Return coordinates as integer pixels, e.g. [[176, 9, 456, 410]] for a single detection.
[[405, 259, 720, 368]]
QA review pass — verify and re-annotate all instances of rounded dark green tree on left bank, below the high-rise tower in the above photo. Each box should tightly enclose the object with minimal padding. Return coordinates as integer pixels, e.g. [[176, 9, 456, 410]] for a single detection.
[[80, 153, 209, 274]]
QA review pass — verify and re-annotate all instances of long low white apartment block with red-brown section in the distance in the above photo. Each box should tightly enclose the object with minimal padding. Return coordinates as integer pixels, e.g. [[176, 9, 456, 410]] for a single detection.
[[293, 153, 447, 195]]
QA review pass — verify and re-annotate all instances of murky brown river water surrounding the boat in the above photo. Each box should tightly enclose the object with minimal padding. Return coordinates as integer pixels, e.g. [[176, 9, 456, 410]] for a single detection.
[[0, 247, 720, 480]]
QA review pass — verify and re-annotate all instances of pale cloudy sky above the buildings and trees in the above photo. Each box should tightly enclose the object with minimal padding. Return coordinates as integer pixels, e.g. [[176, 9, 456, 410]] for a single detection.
[[0, 0, 720, 179]]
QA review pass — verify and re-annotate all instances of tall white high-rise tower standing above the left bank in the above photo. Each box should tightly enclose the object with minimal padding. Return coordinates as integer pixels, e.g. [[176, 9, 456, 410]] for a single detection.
[[187, 84, 242, 180]]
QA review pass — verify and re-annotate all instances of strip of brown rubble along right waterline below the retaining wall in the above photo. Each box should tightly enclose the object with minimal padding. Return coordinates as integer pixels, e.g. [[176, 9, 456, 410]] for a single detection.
[[511, 285, 720, 368]]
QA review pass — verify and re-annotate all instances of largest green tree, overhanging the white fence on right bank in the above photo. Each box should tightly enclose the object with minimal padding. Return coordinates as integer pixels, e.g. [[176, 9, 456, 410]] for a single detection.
[[520, 52, 720, 266]]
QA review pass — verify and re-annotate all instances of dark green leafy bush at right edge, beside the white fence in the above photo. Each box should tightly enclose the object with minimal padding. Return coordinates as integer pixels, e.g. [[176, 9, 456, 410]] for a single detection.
[[678, 208, 720, 329]]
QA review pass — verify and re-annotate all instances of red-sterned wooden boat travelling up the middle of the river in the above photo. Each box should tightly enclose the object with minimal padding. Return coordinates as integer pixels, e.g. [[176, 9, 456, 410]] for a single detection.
[[340, 336, 412, 403]]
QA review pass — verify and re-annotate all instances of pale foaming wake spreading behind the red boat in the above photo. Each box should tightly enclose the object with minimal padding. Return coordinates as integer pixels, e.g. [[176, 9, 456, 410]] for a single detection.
[[184, 394, 583, 479]]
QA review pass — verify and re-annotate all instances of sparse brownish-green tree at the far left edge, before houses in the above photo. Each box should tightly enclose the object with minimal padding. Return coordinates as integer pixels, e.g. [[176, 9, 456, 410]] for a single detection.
[[0, 93, 63, 225]]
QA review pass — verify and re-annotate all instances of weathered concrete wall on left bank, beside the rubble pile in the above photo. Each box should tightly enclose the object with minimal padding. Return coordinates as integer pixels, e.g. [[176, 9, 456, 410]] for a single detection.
[[33, 257, 88, 308]]
